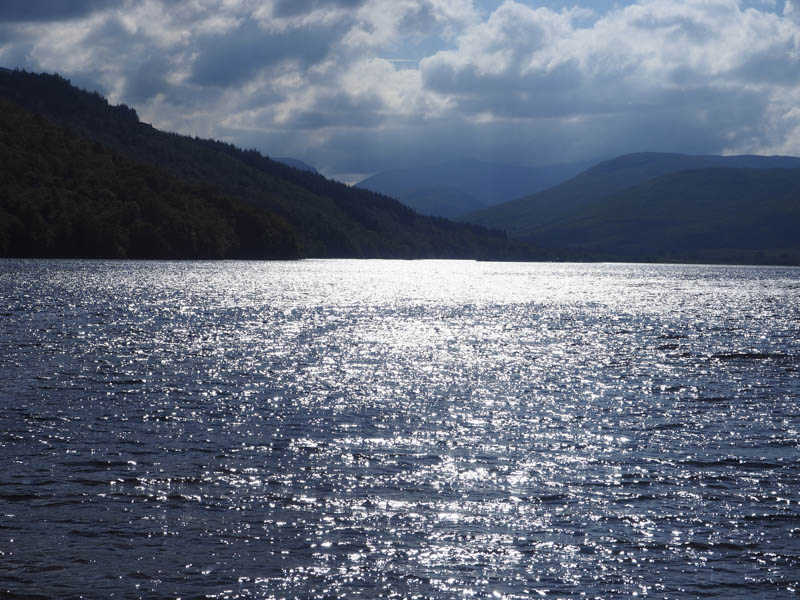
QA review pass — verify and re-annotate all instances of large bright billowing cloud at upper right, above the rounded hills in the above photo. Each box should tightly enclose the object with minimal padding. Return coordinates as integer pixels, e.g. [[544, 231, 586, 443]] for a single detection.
[[420, 0, 800, 159]]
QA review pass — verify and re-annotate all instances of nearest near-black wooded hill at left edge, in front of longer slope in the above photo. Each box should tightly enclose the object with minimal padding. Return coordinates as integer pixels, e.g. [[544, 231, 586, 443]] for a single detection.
[[0, 98, 298, 259]]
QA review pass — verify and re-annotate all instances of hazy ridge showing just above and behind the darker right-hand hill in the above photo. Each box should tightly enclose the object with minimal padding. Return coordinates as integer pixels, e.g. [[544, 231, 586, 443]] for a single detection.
[[462, 152, 800, 238]]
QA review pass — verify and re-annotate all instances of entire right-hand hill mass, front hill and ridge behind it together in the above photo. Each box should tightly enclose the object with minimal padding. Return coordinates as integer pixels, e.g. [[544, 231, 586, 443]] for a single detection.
[[463, 153, 800, 264]]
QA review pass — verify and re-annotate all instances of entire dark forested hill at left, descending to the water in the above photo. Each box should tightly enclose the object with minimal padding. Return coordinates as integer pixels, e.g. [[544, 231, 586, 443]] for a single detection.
[[0, 70, 512, 259]]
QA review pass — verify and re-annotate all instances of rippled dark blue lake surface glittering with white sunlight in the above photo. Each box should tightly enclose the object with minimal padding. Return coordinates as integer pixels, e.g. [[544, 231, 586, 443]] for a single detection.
[[0, 261, 800, 598]]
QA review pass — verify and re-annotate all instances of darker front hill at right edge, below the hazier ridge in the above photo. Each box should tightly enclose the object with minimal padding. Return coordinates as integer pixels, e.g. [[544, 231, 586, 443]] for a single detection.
[[536, 168, 800, 264]]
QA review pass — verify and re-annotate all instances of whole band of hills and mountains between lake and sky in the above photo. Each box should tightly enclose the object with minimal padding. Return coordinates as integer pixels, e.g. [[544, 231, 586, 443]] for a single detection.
[[0, 70, 800, 265]]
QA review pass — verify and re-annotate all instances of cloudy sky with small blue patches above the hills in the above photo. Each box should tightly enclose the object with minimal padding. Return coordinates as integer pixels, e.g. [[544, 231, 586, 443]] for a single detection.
[[0, 0, 800, 182]]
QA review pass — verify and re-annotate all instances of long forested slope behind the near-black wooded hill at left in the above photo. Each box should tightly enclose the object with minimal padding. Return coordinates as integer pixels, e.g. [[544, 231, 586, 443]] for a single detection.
[[0, 71, 520, 259]]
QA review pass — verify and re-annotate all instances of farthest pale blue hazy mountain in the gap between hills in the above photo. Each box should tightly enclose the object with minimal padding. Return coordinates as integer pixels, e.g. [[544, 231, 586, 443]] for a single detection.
[[356, 159, 585, 218]]
